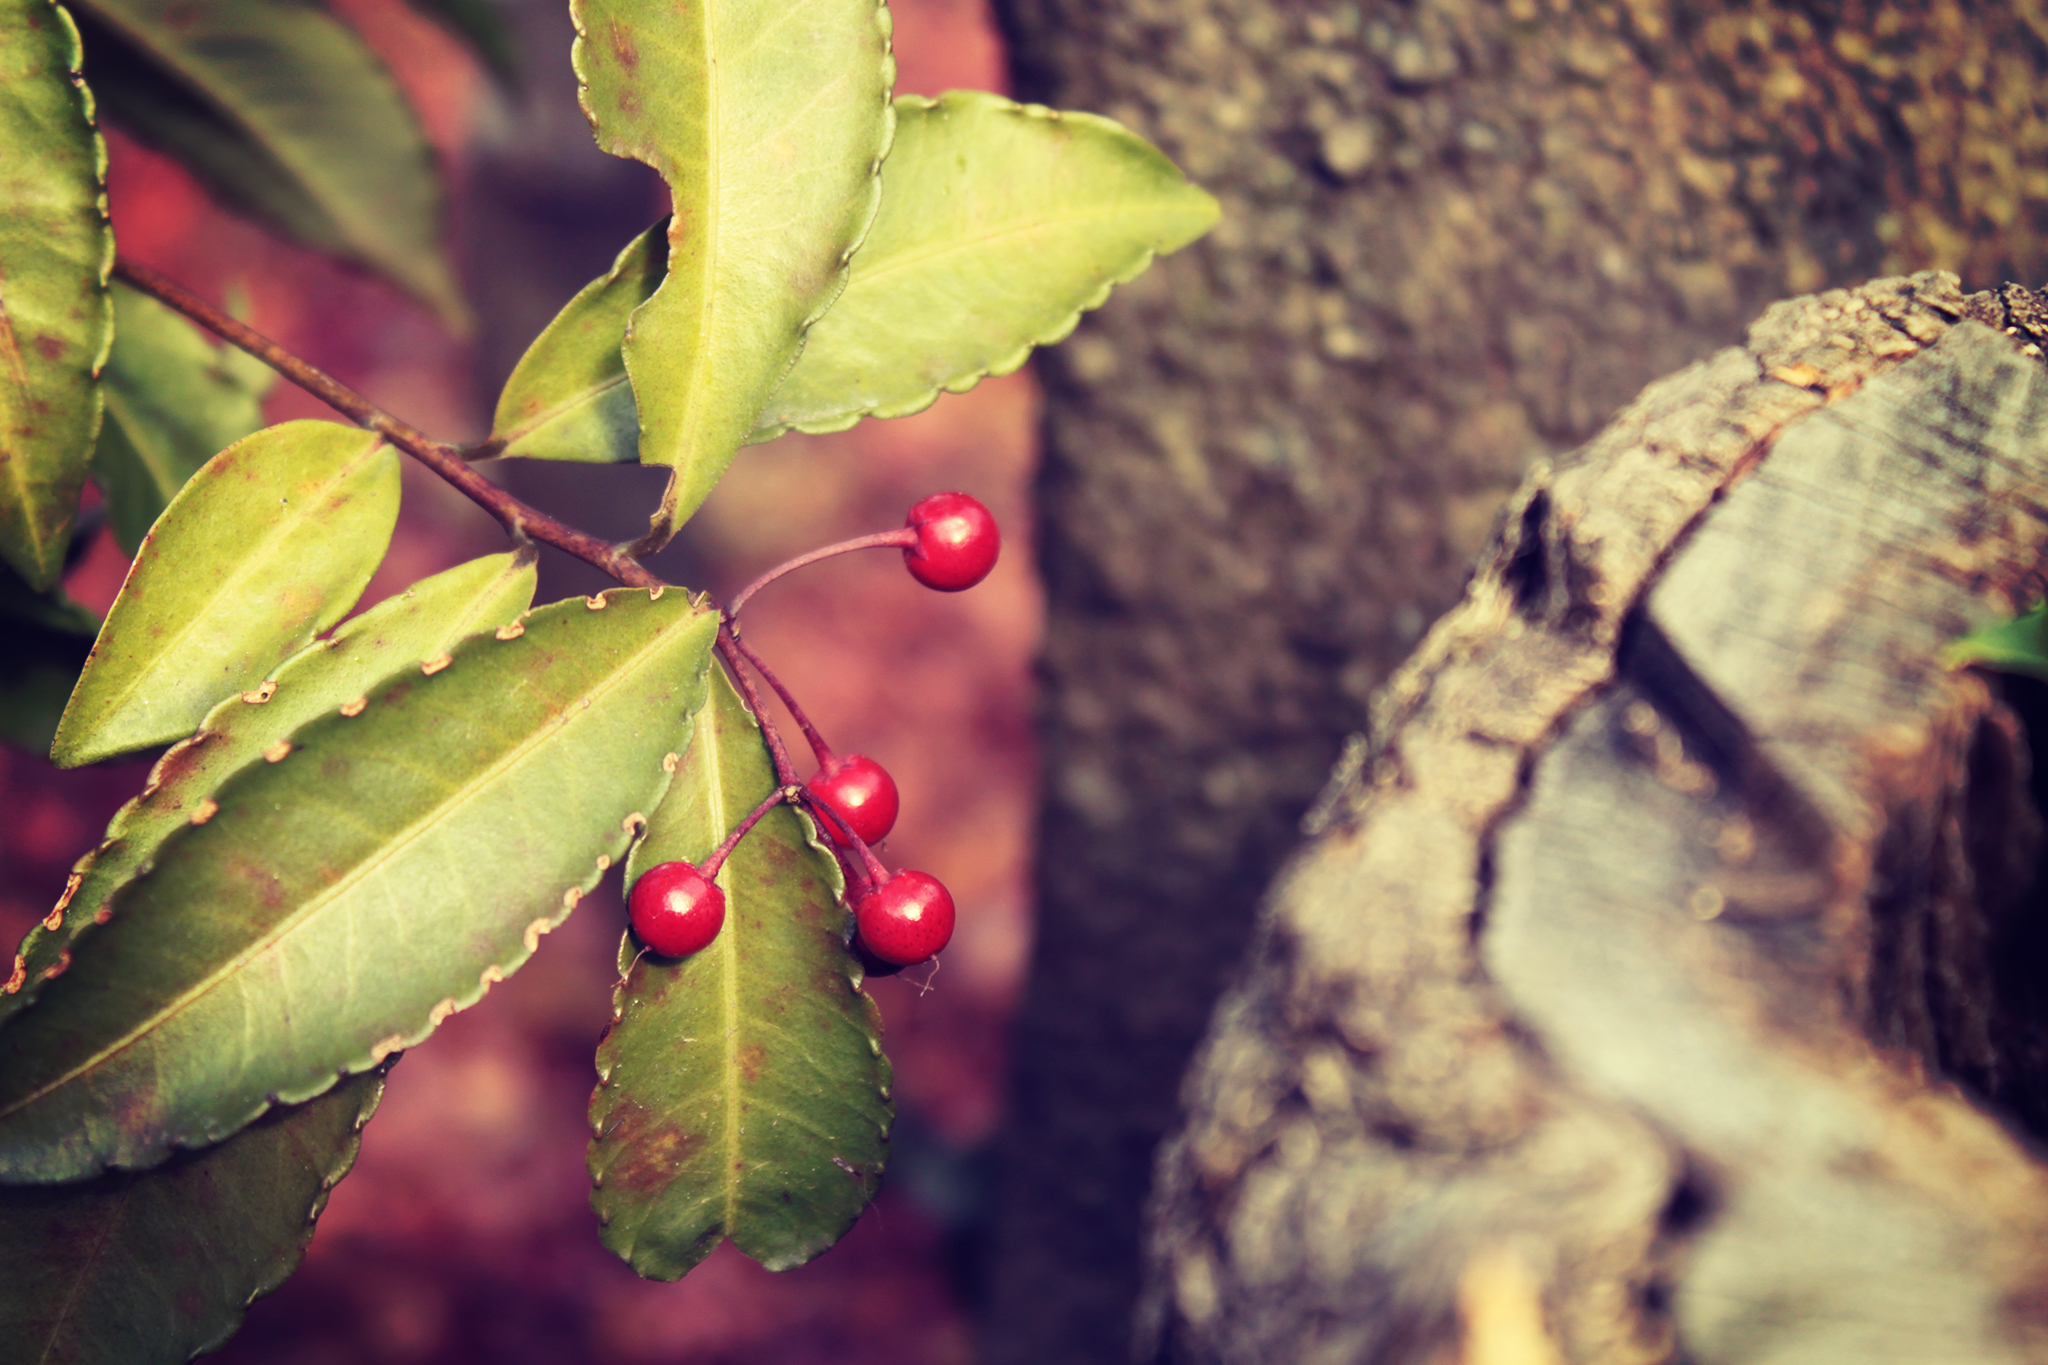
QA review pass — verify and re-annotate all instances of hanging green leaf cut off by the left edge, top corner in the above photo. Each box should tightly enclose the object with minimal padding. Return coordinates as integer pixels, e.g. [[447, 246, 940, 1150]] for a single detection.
[[0, 0, 115, 589]]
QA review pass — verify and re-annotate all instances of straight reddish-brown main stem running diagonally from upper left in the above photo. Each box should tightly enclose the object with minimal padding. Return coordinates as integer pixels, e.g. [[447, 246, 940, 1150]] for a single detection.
[[115, 258, 662, 587]]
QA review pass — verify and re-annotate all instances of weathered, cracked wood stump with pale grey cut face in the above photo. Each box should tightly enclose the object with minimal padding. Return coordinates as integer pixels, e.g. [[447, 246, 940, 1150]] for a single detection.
[[1141, 274, 2048, 1365]]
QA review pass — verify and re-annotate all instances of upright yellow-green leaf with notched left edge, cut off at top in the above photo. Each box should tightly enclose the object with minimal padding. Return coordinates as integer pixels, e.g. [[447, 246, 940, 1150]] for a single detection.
[[569, 0, 895, 544]]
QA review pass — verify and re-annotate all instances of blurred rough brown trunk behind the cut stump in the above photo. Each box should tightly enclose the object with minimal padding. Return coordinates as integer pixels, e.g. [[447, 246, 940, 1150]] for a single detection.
[[983, 0, 2048, 1365]]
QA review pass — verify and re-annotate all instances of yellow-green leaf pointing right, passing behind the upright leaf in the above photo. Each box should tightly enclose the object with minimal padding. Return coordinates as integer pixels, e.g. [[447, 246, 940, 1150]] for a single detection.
[[479, 90, 1217, 463]]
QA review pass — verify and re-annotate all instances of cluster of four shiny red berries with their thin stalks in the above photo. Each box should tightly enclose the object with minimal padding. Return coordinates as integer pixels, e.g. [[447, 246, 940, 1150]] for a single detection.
[[627, 493, 1001, 976]]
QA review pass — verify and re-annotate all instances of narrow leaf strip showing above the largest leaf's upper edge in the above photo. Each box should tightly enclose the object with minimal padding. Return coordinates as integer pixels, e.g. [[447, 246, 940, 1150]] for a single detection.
[[0, 548, 535, 1023]]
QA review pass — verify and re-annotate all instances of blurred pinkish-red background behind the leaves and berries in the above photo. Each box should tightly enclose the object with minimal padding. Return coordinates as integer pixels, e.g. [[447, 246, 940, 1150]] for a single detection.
[[0, 0, 1038, 1365]]
